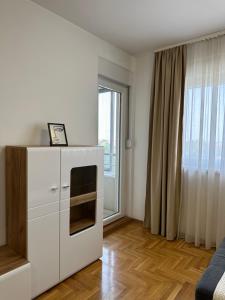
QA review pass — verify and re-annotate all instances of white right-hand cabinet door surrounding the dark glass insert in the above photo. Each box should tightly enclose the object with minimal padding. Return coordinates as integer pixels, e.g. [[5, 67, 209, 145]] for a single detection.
[[60, 147, 104, 280]]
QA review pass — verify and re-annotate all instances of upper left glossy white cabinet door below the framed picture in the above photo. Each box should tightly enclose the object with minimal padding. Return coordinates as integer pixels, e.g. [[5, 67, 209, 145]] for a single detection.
[[27, 147, 60, 208]]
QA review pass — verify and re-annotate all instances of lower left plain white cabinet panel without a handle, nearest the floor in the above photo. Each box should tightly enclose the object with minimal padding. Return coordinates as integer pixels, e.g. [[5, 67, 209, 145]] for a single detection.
[[28, 213, 59, 297]]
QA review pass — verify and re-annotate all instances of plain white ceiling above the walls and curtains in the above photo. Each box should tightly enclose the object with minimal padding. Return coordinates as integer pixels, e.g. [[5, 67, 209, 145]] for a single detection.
[[32, 0, 225, 54]]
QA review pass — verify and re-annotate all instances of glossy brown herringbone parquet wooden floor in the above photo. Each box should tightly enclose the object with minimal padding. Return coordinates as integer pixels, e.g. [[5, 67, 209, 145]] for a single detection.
[[38, 221, 213, 300]]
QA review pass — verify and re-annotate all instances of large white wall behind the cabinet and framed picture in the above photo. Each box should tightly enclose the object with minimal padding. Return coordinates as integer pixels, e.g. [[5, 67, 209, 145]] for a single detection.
[[0, 0, 135, 244]]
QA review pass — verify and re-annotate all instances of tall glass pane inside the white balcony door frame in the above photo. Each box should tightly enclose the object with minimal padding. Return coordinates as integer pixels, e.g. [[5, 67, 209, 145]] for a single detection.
[[98, 86, 121, 218]]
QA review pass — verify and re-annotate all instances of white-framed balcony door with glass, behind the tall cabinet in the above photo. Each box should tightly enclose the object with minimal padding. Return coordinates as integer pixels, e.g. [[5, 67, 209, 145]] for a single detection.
[[98, 79, 128, 224]]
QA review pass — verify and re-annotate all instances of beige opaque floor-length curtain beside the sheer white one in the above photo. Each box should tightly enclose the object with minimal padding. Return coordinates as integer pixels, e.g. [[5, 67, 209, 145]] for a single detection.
[[144, 46, 186, 240]]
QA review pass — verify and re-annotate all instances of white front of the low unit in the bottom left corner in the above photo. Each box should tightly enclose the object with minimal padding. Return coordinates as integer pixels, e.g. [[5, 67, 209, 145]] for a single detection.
[[0, 263, 31, 300]]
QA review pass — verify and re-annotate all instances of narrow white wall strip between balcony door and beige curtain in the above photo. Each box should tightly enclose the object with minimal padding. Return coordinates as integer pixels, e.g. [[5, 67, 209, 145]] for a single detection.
[[131, 52, 154, 220]]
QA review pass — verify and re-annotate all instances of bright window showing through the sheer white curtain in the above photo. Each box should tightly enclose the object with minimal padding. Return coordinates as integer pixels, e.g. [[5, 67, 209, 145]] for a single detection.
[[183, 85, 225, 170]]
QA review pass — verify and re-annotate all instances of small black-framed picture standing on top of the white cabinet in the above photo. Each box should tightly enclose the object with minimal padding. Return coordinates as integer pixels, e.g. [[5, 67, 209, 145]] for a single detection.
[[48, 123, 68, 146]]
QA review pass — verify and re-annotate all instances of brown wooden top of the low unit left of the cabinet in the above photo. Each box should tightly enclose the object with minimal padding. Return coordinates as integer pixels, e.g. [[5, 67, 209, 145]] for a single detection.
[[0, 245, 27, 275]]
